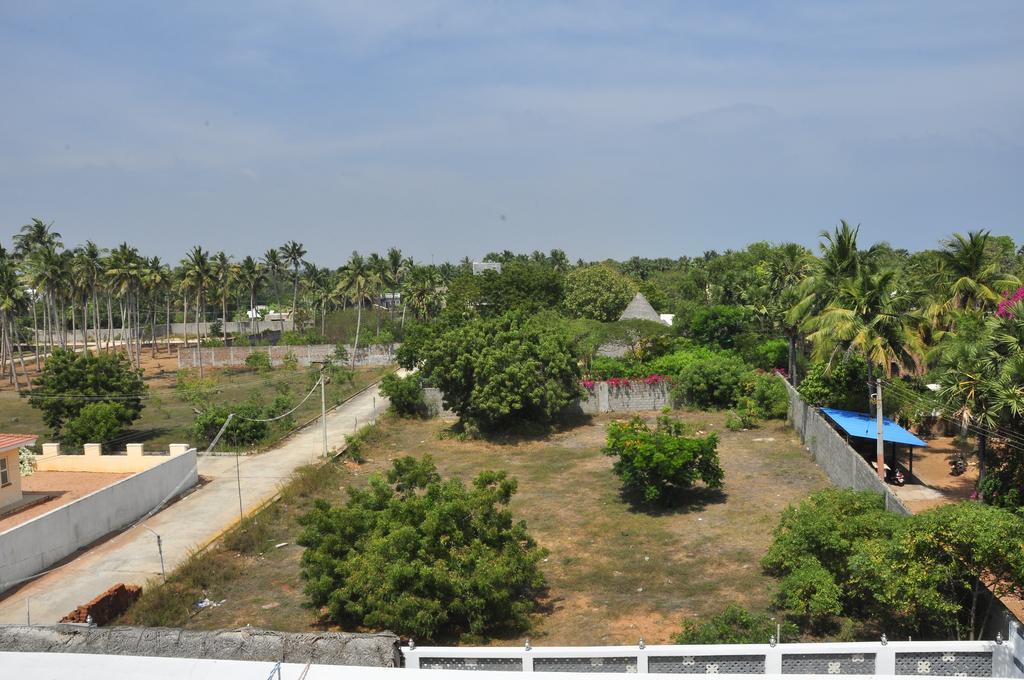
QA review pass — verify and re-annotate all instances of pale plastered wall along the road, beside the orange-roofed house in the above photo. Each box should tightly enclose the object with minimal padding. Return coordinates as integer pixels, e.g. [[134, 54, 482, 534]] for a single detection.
[[0, 449, 199, 593]]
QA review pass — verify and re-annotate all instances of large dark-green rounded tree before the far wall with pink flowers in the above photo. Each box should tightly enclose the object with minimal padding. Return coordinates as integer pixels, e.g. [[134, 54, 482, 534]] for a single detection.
[[417, 312, 580, 428]]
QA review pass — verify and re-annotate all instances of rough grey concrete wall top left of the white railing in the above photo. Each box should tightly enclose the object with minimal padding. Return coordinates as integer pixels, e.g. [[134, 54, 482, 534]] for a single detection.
[[0, 625, 400, 663]]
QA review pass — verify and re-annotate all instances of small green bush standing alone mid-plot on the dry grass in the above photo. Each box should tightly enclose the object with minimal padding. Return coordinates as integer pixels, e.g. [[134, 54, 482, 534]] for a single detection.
[[604, 415, 724, 504]]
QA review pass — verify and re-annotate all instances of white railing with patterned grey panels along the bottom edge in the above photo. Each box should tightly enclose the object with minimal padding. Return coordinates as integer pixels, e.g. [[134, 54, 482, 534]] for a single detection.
[[401, 625, 1024, 678]]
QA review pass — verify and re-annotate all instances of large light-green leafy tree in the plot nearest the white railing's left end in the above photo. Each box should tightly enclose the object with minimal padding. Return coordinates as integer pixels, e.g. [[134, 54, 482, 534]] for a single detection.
[[299, 456, 546, 640]]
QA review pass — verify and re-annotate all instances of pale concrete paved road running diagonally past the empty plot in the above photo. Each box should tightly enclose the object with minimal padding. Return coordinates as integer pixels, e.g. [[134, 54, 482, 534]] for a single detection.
[[0, 378, 387, 624]]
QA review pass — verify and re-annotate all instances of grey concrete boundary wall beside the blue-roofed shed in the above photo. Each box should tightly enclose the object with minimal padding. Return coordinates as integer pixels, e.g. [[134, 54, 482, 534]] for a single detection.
[[785, 382, 910, 515]]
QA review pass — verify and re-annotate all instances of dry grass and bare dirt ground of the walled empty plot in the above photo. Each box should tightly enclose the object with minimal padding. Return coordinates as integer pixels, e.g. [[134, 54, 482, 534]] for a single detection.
[[178, 413, 828, 645]]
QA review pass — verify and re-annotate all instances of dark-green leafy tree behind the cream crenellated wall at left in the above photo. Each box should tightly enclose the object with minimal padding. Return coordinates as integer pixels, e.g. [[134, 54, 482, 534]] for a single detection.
[[29, 348, 147, 436]]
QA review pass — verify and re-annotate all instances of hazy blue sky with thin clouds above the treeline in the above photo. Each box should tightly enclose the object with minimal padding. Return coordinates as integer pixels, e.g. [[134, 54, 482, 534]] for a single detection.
[[0, 0, 1024, 265]]
